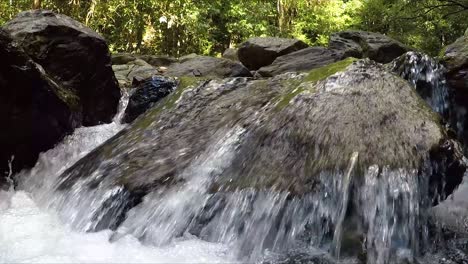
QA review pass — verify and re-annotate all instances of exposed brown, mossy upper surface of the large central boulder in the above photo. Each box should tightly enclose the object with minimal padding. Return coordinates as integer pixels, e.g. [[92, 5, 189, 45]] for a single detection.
[[57, 61, 461, 214]]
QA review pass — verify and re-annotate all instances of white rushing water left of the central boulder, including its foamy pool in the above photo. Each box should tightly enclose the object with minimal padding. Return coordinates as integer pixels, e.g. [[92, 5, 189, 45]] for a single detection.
[[0, 95, 236, 263]]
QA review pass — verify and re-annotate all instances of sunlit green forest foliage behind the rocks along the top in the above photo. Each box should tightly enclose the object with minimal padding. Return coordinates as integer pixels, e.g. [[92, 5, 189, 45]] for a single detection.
[[0, 0, 468, 56]]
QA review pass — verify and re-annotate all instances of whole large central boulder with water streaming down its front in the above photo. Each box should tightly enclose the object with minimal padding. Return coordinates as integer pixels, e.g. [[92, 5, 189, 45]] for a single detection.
[[54, 60, 465, 263]]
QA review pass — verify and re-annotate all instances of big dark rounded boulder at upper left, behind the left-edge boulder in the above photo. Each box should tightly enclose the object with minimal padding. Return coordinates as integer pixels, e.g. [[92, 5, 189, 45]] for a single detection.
[[4, 10, 120, 126]]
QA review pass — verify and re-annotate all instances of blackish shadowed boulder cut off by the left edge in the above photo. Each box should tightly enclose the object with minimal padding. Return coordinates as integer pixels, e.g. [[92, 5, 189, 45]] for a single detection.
[[0, 29, 74, 189]]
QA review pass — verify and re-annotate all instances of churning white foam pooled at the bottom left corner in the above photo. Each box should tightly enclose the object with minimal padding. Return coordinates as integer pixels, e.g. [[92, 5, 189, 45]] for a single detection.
[[0, 192, 234, 263]]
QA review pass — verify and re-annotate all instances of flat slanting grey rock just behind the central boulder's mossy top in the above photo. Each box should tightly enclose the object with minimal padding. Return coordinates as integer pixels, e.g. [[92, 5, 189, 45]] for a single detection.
[[258, 47, 344, 77]]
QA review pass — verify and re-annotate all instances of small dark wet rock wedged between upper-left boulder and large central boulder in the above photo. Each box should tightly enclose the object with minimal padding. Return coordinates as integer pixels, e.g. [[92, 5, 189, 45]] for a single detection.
[[123, 76, 176, 123]]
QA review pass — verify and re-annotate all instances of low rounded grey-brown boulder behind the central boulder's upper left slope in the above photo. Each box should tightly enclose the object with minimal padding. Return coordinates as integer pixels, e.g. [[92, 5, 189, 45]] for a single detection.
[[164, 55, 252, 78]]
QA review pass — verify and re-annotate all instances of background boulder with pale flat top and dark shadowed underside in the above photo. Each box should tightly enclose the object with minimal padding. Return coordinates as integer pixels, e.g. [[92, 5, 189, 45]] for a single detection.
[[237, 37, 308, 70]]
